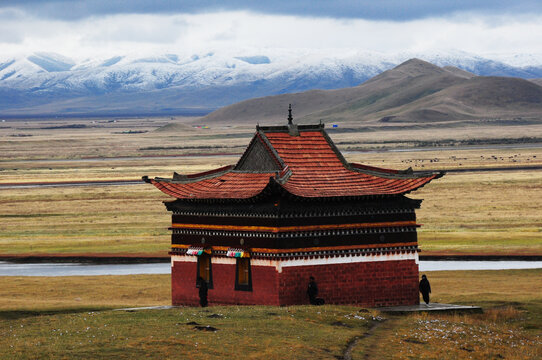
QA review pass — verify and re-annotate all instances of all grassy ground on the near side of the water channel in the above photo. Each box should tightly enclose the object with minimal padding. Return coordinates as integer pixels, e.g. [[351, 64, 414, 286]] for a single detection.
[[0, 270, 542, 359]]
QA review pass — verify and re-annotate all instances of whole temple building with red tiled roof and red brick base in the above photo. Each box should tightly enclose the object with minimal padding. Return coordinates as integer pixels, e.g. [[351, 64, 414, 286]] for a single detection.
[[143, 110, 443, 307]]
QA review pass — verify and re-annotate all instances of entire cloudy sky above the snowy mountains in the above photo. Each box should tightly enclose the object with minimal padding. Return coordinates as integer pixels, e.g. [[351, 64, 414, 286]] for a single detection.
[[0, 0, 542, 59]]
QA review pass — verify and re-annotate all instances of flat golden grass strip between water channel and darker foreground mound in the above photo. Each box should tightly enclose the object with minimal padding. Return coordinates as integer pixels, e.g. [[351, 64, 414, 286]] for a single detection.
[[0, 269, 542, 312]]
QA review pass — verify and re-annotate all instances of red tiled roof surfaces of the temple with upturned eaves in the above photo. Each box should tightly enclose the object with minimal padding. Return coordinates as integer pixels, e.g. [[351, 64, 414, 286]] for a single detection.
[[147, 127, 442, 199]]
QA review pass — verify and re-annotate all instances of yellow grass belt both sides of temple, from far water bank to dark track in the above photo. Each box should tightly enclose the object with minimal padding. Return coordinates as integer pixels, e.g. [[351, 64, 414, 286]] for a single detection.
[[0, 167, 542, 255]]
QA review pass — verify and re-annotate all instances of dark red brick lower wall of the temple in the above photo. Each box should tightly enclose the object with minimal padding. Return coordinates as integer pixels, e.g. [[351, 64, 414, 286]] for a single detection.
[[171, 260, 419, 307]]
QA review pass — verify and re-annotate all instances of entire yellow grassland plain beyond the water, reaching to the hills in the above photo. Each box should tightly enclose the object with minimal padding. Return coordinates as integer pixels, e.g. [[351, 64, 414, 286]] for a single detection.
[[0, 118, 542, 255]]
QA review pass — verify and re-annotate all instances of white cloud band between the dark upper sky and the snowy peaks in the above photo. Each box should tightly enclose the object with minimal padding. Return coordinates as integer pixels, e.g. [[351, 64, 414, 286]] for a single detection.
[[0, 10, 542, 59]]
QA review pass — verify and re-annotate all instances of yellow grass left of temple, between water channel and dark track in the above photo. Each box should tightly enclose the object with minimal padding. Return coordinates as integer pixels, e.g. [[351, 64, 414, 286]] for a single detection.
[[0, 183, 171, 255]]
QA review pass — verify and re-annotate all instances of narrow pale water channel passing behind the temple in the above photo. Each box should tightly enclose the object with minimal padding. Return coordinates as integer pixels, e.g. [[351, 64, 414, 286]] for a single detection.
[[0, 260, 542, 276]]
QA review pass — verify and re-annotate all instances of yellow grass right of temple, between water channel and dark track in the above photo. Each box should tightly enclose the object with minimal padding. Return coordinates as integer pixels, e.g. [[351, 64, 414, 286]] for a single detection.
[[411, 171, 542, 255]]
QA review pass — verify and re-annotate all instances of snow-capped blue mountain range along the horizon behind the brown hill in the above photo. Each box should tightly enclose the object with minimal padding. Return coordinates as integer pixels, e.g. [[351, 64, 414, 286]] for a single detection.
[[0, 49, 542, 116]]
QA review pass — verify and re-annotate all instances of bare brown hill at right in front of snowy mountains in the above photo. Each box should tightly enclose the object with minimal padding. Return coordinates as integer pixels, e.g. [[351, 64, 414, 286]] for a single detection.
[[198, 59, 542, 124]]
